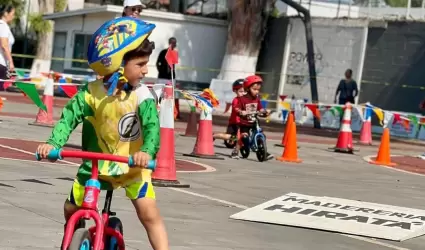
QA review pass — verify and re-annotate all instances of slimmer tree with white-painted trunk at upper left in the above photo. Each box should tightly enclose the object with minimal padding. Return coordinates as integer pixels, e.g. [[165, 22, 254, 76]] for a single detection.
[[29, 0, 67, 75]]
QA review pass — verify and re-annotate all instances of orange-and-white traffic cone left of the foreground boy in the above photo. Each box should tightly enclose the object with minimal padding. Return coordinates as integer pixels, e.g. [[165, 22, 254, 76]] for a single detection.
[[28, 74, 54, 127]]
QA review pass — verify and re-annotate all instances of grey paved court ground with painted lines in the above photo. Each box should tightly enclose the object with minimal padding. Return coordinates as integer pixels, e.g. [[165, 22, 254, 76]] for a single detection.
[[0, 95, 425, 250]]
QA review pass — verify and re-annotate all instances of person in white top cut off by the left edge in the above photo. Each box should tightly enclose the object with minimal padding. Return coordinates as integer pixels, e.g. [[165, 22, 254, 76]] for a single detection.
[[0, 5, 15, 79]]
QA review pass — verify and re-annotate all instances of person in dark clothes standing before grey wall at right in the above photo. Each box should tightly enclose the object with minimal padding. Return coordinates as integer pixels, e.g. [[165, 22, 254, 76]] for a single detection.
[[334, 69, 359, 105]]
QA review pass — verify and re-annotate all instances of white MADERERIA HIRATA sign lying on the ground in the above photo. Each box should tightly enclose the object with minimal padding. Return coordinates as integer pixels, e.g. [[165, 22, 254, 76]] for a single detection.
[[230, 193, 425, 241]]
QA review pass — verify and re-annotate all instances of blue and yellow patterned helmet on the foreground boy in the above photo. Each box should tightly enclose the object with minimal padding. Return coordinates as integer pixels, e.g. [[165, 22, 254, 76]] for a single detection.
[[87, 17, 155, 95]]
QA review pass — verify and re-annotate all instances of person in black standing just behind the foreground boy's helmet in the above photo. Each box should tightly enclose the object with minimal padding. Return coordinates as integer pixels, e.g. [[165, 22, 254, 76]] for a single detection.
[[156, 37, 180, 120]]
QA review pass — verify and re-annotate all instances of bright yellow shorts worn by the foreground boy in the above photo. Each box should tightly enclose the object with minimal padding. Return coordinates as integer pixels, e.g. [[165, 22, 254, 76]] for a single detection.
[[68, 179, 155, 207]]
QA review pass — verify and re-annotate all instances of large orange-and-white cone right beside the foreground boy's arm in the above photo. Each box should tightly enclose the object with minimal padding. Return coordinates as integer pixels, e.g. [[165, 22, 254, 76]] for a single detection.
[[152, 85, 190, 187]]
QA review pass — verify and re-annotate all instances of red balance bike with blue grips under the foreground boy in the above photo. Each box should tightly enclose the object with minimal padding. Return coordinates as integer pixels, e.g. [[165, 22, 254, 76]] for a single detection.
[[35, 149, 156, 250]]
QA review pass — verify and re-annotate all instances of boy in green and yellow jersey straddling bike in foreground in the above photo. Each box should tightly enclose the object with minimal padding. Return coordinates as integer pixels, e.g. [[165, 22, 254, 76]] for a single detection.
[[37, 17, 169, 250]]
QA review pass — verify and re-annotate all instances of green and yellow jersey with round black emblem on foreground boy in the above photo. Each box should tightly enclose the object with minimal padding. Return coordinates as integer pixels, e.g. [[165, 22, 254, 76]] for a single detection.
[[47, 80, 160, 189]]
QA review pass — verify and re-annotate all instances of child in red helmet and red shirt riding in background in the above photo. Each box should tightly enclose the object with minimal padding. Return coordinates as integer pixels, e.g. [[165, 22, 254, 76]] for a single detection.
[[235, 75, 273, 159]]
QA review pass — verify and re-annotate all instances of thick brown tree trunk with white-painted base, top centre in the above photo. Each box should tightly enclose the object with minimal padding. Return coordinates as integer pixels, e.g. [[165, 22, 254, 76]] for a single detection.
[[218, 0, 276, 81]]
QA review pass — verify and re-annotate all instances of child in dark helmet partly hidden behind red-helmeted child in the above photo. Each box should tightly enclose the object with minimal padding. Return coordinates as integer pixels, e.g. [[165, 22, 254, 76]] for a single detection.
[[213, 79, 245, 159]]
